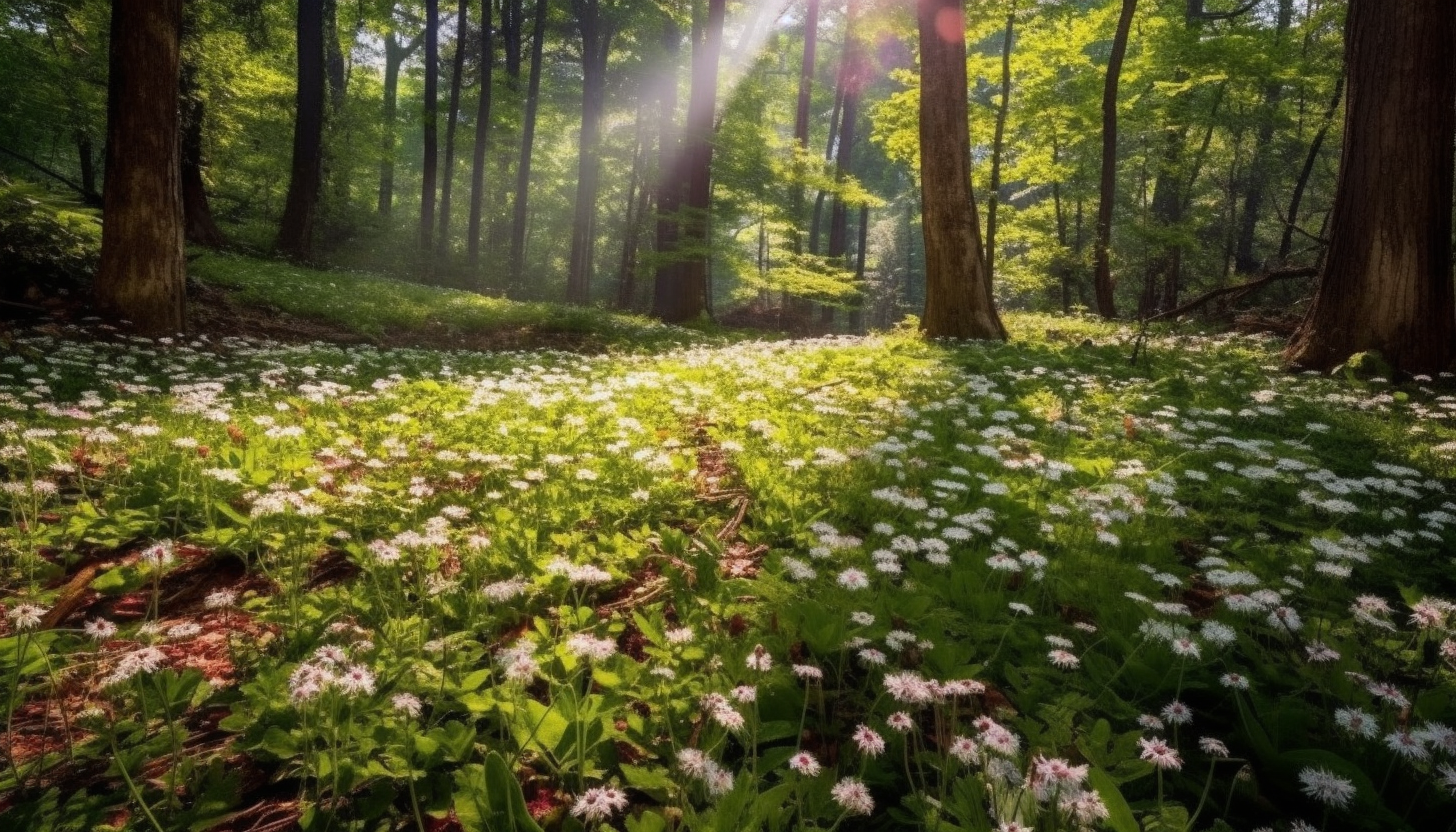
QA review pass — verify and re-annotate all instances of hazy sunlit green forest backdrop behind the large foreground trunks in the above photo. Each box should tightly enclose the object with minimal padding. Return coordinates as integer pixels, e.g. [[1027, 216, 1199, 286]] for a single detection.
[[0, 0, 1344, 329]]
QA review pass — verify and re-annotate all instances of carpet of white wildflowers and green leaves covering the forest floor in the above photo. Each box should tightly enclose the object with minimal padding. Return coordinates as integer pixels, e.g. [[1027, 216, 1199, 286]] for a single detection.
[[0, 316, 1456, 832]]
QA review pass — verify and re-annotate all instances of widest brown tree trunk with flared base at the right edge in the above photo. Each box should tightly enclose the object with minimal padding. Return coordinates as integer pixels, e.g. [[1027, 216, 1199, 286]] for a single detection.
[[1284, 0, 1456, 373]]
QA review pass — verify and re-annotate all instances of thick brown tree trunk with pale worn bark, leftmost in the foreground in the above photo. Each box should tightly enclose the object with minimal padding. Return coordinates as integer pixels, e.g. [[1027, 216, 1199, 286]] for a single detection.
[[95, 0, 186, 337]]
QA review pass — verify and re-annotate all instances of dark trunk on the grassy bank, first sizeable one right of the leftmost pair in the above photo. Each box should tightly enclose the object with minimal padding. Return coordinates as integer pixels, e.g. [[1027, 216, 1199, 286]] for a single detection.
[[275, 0, 325, 261]]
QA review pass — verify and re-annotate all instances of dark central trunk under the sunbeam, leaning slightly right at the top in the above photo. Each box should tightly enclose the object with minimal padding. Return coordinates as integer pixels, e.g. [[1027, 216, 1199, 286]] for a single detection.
[[654, 0, 727, 322]]
